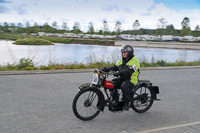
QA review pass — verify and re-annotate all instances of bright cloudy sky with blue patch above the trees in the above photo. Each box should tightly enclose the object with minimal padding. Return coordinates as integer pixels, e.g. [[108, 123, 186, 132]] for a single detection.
[[0, 0, 200, 32]]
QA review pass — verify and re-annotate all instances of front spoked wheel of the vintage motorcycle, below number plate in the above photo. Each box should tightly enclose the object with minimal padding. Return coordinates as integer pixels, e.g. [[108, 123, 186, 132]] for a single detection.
[[72, 89, 102, 121]]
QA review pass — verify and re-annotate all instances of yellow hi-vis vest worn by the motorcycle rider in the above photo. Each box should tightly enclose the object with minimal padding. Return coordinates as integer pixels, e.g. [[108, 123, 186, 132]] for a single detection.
[[116, 56, 140, 85]]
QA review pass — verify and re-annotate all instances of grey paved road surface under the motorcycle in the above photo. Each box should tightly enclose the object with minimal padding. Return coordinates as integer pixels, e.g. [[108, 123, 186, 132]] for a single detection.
[[0, 69, 200, 133]]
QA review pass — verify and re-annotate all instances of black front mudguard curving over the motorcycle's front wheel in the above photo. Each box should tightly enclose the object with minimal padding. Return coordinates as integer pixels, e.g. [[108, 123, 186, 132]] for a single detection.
[[79, 83, 105, 112]]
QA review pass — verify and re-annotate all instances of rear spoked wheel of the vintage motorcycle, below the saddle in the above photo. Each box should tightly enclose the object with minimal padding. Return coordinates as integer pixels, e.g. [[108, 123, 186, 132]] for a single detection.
[[131, 86, 154, 113]]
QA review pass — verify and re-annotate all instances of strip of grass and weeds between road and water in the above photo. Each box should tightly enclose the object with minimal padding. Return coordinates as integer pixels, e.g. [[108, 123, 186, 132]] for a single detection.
[[0, 58, 200, 71]]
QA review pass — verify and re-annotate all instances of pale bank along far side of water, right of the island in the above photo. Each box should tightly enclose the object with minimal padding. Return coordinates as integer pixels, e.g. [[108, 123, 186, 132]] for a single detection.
[[115, 41, 200, 50]]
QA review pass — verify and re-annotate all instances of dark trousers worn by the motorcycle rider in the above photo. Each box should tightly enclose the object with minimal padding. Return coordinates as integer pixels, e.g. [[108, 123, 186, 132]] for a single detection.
[[111, 78, 134, 104]]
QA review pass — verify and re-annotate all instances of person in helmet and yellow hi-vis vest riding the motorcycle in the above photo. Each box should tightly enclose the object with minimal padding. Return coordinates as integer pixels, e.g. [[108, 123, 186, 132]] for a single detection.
[[102, 45, 140, 110]]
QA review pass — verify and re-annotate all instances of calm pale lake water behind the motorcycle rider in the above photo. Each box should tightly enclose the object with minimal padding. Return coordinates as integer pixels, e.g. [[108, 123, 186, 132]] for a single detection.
[[0, 40, 200, 66]]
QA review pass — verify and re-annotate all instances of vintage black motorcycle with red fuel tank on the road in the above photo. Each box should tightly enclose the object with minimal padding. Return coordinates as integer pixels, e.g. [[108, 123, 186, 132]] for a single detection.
[[72, 69, 160, 121]]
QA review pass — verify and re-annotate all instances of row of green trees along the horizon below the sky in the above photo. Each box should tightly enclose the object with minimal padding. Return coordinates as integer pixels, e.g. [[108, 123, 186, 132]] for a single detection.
[[0, 17, 200, 37]]
